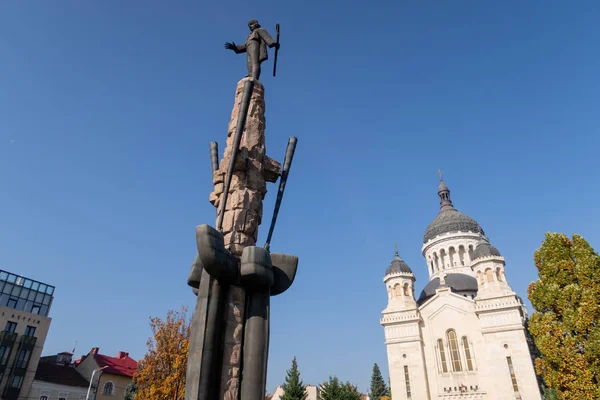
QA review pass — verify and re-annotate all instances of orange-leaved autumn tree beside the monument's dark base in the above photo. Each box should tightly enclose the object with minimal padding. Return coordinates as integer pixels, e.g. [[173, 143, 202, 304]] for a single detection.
[[133, 307, 191, 400]]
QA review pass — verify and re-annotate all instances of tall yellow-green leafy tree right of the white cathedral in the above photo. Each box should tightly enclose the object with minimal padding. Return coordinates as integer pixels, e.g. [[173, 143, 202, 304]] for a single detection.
[[528, 233, 600, 400]]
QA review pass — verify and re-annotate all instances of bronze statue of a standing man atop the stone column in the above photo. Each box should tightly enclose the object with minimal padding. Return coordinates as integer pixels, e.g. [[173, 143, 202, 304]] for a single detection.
[[225, 19, 279, 80]]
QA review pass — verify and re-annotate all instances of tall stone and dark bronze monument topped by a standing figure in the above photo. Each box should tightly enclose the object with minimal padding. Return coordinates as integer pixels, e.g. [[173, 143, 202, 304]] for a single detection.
[[185, 20, 298, 400]]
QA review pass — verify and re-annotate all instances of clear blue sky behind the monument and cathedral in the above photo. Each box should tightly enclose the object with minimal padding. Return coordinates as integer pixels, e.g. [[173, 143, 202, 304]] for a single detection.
[[0, 0, 600, 391]]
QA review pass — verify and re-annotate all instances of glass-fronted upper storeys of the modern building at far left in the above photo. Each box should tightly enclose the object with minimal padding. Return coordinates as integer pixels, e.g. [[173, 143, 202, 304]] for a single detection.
[[0, 270, 54, 317]]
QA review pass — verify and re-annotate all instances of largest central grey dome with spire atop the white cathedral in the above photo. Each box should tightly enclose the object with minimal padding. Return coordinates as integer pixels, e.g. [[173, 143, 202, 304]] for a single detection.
[[423, 177, 484, 243]]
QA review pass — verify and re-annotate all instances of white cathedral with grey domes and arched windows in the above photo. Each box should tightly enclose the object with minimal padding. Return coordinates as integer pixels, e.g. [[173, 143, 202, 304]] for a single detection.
[[381, 178, 541, 400]]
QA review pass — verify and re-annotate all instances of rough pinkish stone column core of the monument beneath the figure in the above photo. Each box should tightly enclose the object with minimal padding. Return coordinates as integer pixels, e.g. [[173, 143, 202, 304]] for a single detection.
[[209, 78, 281, 400]]
